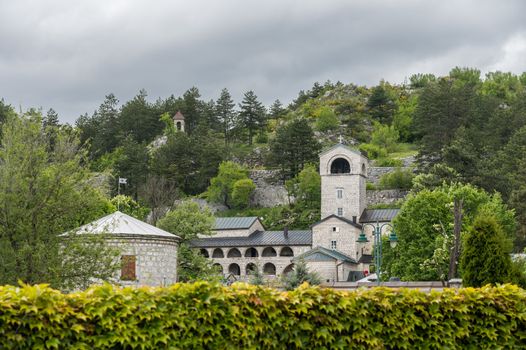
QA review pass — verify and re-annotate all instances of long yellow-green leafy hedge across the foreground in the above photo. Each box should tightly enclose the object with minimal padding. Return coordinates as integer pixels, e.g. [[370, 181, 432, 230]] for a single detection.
[[0, 283, 526, 349]]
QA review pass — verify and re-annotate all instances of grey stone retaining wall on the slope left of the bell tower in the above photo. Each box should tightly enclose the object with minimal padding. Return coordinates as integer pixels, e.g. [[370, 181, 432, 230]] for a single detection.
[[249, 170, 289, 207]]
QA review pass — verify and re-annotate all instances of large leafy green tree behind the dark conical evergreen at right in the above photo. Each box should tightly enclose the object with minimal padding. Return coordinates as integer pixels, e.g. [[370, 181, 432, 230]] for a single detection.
[[384, 184, 515, 281]]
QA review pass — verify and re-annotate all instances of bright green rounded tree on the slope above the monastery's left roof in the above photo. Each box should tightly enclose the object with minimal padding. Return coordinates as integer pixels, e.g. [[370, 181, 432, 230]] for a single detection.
[[207, 161, 252, 208]]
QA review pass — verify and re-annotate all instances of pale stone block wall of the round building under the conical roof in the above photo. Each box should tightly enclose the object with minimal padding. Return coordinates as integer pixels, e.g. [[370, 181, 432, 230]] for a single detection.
[[108, 235, 178, 286]]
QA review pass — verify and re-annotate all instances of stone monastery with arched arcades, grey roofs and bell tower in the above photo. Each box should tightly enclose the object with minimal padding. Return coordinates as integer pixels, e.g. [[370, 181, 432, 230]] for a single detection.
[[192, 144, 398, 284]]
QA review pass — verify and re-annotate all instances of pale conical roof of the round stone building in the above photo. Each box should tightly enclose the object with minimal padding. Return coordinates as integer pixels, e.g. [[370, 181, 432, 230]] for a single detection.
[[68, 211, 180, 239]]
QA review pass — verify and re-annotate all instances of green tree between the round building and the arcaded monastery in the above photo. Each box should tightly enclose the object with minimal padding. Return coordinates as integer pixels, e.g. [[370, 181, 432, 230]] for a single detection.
[[157, 201, 217, 282]]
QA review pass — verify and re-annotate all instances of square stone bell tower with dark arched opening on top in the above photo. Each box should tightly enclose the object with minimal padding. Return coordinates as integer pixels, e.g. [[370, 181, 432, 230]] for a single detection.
[[320, 143, 368, 222]]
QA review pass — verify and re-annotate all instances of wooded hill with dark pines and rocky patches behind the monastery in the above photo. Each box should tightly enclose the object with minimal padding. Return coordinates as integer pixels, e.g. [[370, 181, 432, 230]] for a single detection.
[[0, 68, 526, 250]]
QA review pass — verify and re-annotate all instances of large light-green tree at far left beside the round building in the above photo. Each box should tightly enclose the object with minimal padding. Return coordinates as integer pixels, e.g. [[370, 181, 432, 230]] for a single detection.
[[0, 116, 114, 288]]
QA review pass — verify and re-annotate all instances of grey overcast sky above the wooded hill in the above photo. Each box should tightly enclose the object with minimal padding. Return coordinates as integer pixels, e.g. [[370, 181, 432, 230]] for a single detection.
[[0, 0, 526, 122]]
